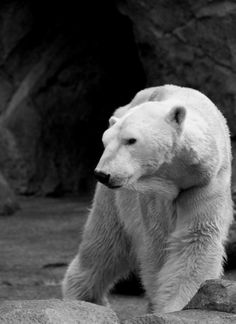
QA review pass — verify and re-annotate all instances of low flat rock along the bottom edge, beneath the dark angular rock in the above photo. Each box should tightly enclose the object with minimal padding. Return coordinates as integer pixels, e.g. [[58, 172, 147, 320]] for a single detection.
[[122, 310, 236, 324]]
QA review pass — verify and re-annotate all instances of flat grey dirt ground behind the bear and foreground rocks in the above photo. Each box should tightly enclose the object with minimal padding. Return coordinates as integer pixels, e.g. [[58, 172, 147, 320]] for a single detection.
[[0, 198, 236, 319]]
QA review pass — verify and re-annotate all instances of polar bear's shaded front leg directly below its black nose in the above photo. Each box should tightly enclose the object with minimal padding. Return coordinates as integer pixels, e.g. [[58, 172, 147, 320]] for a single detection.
[[62, 184, 134, 304]]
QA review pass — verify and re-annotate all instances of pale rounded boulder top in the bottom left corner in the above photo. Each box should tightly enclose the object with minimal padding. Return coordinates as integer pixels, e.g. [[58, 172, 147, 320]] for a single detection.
[[0, 299, 119, 324]]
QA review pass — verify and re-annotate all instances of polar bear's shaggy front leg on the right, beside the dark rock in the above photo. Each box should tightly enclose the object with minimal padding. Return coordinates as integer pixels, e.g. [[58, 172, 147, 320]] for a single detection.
[[153, 184, 232, 313]]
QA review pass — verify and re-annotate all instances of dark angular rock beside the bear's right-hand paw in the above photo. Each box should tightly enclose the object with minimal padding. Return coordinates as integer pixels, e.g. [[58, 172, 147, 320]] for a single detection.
[[185, 279, 236, 314]]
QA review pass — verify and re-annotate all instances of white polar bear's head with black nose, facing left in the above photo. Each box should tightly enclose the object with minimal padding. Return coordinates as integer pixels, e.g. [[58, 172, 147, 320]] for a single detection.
[[95, 100, 186, 190]]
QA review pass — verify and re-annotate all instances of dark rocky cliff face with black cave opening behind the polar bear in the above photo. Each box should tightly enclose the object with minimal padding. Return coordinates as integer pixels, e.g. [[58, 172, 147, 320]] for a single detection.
[[0, 0, 236, 195]]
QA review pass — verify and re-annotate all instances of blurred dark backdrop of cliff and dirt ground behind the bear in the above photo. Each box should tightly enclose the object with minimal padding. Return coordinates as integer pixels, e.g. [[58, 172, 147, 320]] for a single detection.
[[0, 0, 236, 314]]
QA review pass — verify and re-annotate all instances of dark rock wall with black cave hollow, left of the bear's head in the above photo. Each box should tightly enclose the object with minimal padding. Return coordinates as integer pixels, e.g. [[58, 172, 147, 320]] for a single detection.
[[0, 0, 144, 195]]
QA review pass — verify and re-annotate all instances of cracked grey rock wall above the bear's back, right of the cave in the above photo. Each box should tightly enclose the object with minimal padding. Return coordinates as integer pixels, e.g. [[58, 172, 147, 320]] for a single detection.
[[119, 0, 236, 136]]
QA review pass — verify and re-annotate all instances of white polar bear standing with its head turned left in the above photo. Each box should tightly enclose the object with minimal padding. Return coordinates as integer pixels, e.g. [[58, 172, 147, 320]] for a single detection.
[[63, 85, 233, 313]]
